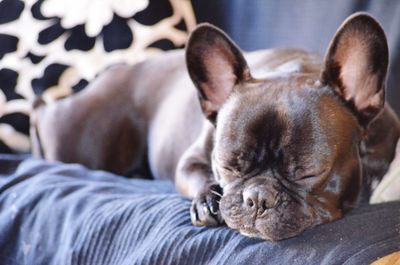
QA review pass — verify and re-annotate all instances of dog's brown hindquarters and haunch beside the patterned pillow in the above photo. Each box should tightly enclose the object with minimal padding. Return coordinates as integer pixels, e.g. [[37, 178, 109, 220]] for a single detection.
[[30, 65, 147, 175]]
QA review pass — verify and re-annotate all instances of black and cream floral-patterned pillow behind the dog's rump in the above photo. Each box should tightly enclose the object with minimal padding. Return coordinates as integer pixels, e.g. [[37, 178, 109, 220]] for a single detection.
[[0, 0, 196, 152]]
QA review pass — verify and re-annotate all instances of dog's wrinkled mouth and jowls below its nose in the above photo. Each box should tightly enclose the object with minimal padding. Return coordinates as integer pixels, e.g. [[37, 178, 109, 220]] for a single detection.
[[220, 187, 316, 241]]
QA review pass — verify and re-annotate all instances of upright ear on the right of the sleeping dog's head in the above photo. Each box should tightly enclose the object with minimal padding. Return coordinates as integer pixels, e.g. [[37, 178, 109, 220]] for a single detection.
[[321, 13, 388, 126]]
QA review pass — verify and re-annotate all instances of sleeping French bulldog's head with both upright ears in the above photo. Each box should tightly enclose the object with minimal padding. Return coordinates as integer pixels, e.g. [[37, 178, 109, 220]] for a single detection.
[[186, 14, 388, 240]]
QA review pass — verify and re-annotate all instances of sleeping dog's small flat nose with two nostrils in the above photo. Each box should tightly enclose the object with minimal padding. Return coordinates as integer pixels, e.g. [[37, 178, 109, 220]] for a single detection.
[[243, 187, 275, 212]]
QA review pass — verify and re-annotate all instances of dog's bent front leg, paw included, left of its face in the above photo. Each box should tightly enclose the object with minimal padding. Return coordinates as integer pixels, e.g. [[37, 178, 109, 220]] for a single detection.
[[175, 120, 223, 226]]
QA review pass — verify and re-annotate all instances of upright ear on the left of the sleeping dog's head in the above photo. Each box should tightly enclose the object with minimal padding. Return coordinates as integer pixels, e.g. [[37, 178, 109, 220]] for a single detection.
[[186, 24, 250, 123]]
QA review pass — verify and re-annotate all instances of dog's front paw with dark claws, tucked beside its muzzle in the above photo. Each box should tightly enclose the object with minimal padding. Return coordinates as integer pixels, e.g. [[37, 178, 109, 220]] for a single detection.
[[190, 184, 224, 226]]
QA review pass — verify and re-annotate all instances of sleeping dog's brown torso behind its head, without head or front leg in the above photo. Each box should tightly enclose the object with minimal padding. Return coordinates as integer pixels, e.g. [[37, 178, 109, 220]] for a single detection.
[[31, 49, 321, 179]]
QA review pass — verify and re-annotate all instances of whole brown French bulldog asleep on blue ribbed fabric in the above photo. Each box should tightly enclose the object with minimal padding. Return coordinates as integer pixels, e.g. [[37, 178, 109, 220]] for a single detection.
[[31, 13, 400, 240]]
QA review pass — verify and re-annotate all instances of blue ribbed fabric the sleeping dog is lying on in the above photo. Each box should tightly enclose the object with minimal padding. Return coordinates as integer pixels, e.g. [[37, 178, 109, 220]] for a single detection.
[[0, 159, 400, 265]]
